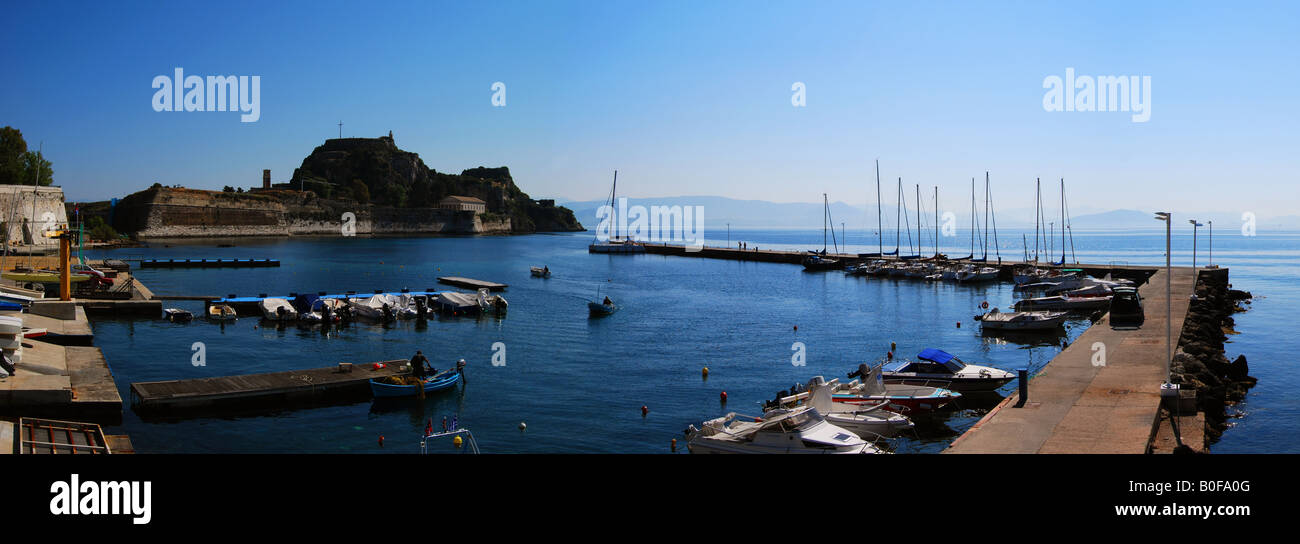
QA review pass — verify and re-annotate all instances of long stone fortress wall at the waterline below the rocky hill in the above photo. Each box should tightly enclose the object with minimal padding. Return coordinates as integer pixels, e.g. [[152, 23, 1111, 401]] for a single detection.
[[113, 187, 511, 238]]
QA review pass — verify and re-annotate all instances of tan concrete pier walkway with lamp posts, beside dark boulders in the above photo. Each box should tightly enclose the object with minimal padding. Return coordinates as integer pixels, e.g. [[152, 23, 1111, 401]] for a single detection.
[[944, 267, 1193, 453]]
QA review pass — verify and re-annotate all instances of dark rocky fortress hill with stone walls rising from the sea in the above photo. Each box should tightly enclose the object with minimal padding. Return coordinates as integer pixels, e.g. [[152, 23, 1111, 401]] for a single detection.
[[111, 135, 584, 238]]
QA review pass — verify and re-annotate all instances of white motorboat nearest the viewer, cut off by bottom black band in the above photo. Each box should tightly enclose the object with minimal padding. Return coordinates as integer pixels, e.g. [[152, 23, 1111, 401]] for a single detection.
[[686, 406, 881, 454]]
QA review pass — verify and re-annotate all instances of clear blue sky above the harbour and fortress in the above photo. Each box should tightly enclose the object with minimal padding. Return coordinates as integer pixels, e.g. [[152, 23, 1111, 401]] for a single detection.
[[0, 0, 1300, 215]]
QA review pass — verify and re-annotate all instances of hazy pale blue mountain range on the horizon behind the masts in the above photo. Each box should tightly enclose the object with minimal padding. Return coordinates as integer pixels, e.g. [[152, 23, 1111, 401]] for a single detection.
[[556, 197, 1300, 232]]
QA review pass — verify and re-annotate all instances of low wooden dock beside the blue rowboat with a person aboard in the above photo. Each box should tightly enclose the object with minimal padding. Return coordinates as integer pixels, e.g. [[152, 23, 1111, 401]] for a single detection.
[[131, 360, 407, 415]]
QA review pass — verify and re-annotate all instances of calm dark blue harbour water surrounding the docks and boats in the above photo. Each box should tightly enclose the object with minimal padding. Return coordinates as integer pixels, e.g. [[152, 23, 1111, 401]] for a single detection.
[[91, 230, 1300, 453]]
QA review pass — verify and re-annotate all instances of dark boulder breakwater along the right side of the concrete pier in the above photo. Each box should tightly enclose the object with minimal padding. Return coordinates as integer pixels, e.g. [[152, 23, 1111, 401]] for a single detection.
[[1170, 269, 1256, 441]]
